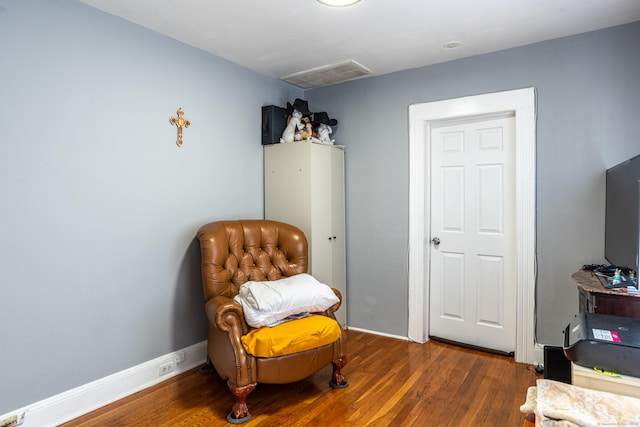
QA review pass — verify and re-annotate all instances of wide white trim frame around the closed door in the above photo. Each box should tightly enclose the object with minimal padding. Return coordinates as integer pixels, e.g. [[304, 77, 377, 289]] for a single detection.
[[407, 88, 542, 364]]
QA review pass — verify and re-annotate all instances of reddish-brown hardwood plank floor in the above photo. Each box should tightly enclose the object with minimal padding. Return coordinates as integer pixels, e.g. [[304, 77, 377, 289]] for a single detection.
[[63, 331, 540, 427]]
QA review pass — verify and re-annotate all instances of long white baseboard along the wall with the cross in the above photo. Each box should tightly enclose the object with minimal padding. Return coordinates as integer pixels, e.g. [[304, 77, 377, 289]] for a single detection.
[[0, 341, 207, 427]]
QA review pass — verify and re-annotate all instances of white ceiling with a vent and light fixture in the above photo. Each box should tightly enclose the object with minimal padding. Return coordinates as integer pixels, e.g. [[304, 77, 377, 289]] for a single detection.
[[80, 0, 640, 87]]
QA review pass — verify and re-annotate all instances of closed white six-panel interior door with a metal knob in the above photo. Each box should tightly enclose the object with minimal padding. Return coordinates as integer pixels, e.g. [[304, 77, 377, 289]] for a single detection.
[[429, 116, 516, 352]]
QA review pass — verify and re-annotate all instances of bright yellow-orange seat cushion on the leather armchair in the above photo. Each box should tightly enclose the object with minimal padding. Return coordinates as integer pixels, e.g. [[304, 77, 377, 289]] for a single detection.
[[242, 314, 342, 357]]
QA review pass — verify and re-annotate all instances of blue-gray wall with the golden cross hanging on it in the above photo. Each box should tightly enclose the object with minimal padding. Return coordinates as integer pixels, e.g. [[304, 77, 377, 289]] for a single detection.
[[0, 0, 302, 414]]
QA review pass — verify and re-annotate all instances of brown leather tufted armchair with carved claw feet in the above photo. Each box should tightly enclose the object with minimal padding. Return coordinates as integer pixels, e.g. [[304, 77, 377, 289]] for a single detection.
[[198, 220, 348, 424]]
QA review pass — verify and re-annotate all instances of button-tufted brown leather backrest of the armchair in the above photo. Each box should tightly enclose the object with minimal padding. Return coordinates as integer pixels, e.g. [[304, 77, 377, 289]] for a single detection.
[[198, 220, 308, 301]]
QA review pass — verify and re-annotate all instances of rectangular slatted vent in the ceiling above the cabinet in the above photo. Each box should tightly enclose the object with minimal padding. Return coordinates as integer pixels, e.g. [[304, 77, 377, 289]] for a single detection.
[[280, 60, 373, 89]]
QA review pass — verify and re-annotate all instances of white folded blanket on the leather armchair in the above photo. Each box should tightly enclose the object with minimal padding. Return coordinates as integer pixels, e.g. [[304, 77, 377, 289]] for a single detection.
[[234, 273, 340, 328]]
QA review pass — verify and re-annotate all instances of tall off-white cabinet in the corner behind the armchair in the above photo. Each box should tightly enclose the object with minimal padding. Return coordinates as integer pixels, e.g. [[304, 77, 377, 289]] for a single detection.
[[264, 141, 347, 328]]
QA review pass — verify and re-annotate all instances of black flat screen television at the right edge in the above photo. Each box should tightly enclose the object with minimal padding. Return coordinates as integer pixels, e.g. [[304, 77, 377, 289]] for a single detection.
[[604, 155, 640, 273]]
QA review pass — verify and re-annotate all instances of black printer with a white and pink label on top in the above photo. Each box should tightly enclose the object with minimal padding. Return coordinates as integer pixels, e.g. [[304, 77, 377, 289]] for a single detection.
[[563, 313, 640, 377]]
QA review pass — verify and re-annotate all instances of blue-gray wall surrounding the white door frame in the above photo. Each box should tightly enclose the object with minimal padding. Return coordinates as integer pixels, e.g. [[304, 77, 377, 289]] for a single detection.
[[305, 23, 640, 345]]
